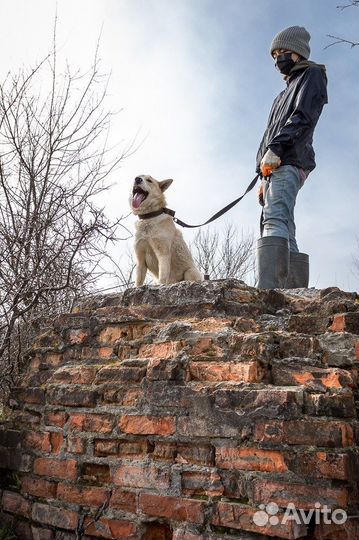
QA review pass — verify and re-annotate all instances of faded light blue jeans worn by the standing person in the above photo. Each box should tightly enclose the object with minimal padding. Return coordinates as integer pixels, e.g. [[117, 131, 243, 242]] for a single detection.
[[262, 165, 305, 252]]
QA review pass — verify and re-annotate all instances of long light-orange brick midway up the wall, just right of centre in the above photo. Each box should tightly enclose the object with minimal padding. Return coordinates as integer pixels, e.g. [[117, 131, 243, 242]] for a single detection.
[[189, 360, 263, 382]]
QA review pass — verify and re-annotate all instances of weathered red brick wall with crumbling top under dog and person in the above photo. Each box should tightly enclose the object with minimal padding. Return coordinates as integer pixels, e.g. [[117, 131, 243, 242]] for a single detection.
[[0, 280, 359, 540]]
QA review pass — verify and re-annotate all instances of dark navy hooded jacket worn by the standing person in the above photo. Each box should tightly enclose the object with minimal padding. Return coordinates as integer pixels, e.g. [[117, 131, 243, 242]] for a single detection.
[[256, 60, 328, 172]]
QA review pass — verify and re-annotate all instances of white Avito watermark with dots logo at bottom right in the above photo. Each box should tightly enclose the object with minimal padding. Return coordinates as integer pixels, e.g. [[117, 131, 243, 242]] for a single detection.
[[252, 502, 348, 527]]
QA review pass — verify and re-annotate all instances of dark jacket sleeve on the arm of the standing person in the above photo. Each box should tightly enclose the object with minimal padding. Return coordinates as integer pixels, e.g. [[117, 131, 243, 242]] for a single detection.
[[268, 67, 328, 157]]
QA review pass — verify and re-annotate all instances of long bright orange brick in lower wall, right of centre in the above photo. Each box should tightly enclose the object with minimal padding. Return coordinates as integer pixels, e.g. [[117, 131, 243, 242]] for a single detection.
[[216, 447, 288, 472]]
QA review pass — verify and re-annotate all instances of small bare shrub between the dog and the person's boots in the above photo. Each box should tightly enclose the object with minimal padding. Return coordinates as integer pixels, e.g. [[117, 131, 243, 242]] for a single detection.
[[192, 224, 255, 280]]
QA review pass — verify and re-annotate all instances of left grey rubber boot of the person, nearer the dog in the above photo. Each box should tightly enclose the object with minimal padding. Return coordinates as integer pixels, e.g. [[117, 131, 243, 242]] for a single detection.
[[257, 236, 289, 289]]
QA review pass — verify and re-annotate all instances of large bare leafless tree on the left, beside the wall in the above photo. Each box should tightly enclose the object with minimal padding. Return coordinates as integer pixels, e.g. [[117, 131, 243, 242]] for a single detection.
[[0, 39, 131, 396]]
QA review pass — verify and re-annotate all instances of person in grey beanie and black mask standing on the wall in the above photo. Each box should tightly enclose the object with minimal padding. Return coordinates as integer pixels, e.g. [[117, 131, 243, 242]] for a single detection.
[[257, 26, 328, 289]]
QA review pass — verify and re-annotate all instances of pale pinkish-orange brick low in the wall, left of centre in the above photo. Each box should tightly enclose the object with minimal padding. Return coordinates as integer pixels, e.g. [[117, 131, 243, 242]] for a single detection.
[[113, 463, 170, 489]]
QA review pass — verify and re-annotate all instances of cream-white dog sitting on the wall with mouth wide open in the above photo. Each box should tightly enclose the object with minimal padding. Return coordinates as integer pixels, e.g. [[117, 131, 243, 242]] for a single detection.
[[130, 174, 203, 287]]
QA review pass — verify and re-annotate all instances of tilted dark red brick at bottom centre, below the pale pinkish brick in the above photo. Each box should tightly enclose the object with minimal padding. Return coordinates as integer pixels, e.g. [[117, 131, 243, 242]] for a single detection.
[[139, 493, 205, 523]]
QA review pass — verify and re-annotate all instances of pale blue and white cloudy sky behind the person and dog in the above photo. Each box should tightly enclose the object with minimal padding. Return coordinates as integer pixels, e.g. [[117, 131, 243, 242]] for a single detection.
[[0, 0, 359, 290]]
